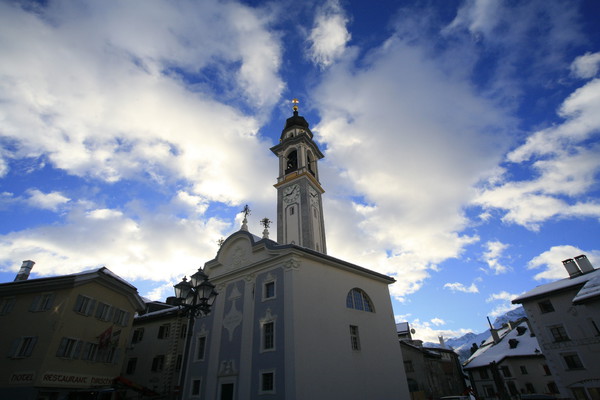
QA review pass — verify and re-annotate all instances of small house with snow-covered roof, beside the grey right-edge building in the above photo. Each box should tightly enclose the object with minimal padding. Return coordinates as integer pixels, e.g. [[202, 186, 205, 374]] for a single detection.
[[463, 319, 558, 400]]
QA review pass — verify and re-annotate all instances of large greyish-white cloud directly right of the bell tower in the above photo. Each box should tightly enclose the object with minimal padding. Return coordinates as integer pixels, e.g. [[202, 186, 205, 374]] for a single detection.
[[313, 29, 512, 298]]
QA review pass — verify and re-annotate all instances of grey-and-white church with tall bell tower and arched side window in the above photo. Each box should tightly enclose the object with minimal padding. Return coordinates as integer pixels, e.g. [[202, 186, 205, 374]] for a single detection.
[[182, 105, 409, 400]]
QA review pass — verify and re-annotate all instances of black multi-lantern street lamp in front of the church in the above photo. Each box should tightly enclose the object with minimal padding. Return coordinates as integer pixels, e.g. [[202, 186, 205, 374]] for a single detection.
[[173, 268, 218, 398]]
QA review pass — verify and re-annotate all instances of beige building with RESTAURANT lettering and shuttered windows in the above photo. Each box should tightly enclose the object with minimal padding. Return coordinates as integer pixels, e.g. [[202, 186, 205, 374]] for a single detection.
[[0, 261, 144, 400]]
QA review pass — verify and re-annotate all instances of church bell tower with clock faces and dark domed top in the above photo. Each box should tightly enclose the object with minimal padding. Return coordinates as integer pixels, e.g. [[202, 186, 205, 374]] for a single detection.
[[271, 99, 327, 254]]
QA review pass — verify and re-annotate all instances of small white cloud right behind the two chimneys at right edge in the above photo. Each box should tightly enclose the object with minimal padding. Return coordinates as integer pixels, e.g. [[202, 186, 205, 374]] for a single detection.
[[527, 245, 600, 281]]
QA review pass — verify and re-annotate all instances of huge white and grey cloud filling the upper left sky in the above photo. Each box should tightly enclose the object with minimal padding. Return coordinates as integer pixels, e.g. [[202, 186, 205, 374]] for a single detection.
[[0, 1, 283, 203]]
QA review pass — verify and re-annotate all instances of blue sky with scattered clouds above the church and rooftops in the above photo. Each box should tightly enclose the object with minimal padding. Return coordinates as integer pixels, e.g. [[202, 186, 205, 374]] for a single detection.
[[0, 0, 600, 341]]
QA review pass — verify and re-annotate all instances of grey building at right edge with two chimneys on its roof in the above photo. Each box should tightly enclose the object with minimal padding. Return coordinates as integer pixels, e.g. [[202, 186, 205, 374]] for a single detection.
[[513, 255, 600, 400]]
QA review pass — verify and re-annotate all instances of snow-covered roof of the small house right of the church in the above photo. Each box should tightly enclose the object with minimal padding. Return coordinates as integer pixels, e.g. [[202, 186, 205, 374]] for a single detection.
[[464, 321, 542, 369]]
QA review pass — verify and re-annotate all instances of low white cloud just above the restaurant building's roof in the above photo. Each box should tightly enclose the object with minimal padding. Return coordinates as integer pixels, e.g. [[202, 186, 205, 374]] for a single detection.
[[0, 197, 233, 282]]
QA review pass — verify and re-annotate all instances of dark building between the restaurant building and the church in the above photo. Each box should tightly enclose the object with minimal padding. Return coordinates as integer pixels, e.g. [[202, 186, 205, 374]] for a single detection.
[[119, 301, 188, 399]]
